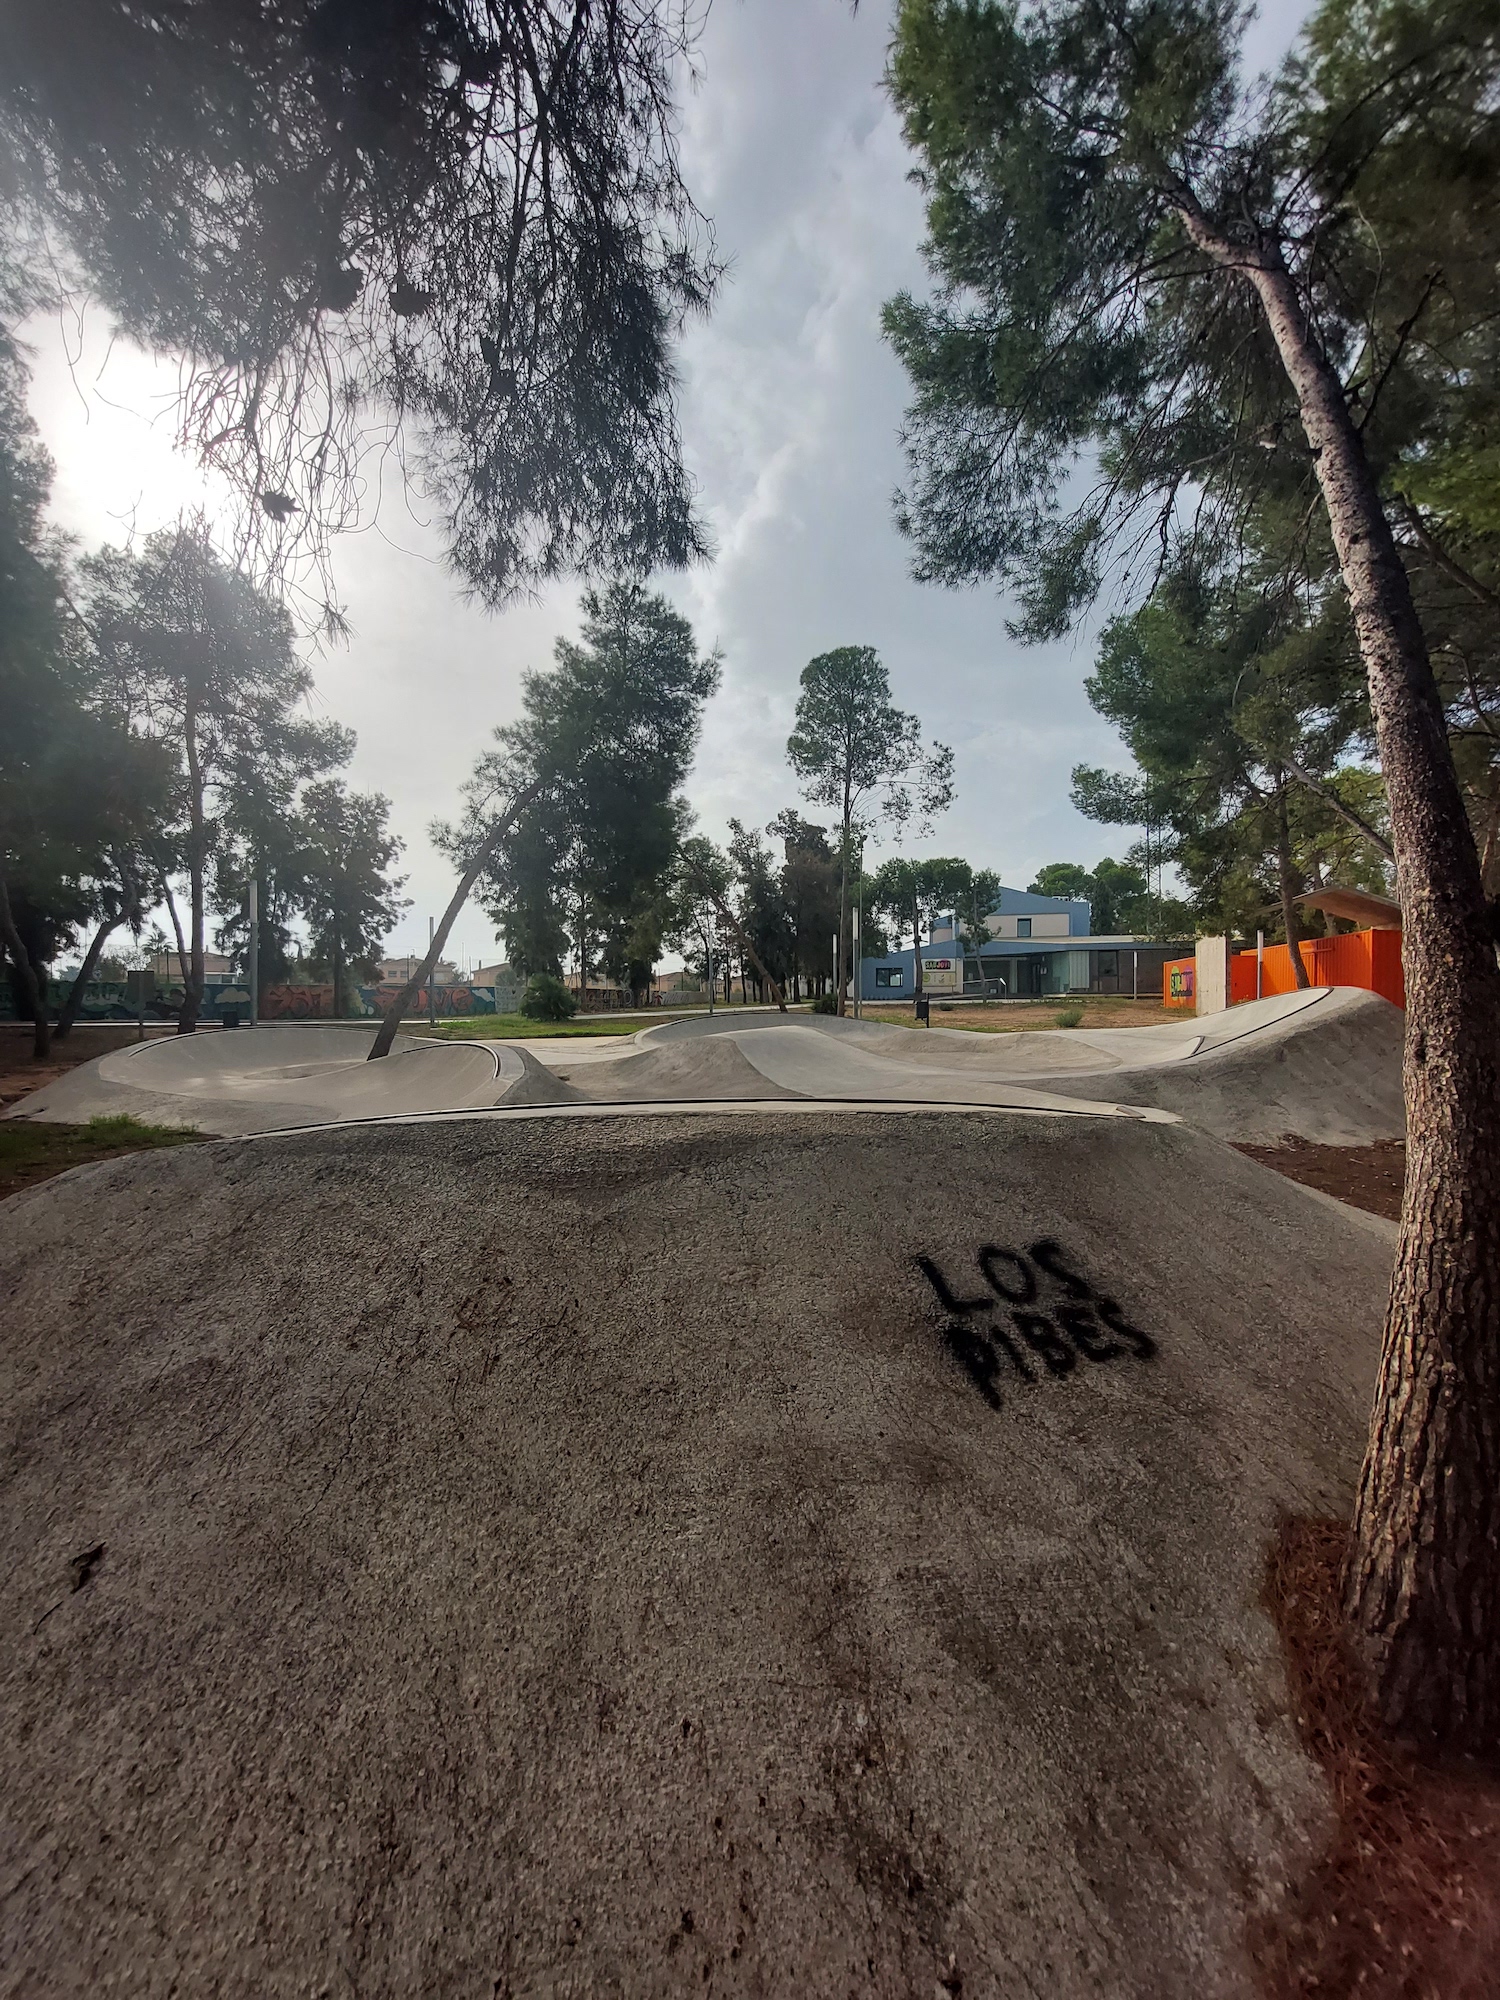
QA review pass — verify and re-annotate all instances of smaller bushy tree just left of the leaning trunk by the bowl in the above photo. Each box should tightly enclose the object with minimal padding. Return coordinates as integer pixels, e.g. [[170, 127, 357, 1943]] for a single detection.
[[296, 778, 410, 1018]]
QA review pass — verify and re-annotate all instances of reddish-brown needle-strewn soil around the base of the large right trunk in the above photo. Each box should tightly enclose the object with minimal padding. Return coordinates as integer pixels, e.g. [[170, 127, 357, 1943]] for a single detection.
[[1250, 1518, 1500, 2000]]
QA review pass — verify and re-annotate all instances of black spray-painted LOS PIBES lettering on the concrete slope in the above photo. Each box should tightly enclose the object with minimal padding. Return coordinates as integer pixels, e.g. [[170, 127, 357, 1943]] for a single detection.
[[916, 1236, 1156, 1410]]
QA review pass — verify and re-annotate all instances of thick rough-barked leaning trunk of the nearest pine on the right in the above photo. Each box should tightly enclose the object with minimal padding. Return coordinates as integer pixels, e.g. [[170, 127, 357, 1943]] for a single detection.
[[1216, 234, 1500, 1750]]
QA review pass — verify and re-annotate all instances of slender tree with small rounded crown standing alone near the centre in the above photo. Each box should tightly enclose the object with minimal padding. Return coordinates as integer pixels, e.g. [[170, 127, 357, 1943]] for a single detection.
[[786, 646, 954, 1014]]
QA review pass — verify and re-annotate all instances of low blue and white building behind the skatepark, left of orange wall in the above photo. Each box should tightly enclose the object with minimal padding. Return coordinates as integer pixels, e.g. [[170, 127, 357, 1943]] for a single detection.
[[860, 888, 1184, 1000]]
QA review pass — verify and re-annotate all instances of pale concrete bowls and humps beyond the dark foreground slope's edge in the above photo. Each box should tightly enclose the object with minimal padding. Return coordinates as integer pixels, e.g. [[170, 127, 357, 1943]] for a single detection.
[[2, 988, 1404, 1144]]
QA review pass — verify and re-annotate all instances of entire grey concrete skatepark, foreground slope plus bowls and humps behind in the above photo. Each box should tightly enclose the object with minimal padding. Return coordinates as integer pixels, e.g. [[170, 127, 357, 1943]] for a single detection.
[[0, 990, 1400, 2000]]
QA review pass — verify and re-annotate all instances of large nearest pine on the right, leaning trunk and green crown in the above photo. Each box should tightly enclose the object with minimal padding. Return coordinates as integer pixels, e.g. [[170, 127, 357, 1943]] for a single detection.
[[886, 0, 1500, 1746]]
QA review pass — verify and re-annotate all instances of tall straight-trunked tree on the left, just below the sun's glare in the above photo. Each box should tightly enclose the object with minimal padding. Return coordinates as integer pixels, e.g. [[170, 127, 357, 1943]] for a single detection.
[[84, 520, 352, 1034]]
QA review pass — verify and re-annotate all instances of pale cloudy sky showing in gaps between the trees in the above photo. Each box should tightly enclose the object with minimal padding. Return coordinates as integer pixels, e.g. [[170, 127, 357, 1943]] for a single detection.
[[30, 0, 1306, 962]]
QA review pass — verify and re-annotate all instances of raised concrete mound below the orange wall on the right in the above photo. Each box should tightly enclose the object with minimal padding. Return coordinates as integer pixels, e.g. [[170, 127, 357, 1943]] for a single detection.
[[1048, 986, 1406, 1146]]
